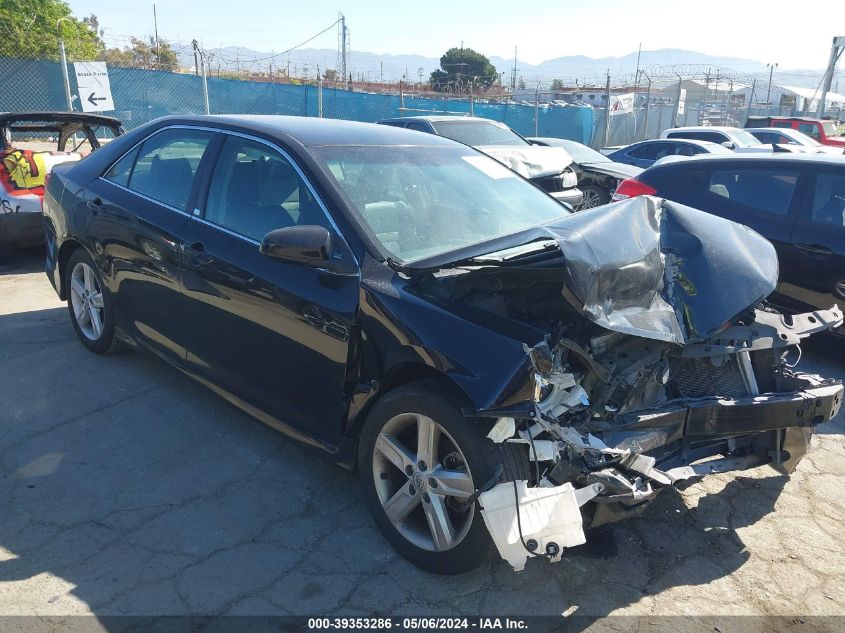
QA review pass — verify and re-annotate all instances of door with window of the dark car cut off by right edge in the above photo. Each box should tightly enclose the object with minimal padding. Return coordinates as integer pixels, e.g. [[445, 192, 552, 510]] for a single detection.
[[781, 169, 845, 308]]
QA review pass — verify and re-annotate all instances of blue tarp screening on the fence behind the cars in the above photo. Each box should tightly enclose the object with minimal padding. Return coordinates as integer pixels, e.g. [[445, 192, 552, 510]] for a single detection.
[[0, 57, 594, 144]]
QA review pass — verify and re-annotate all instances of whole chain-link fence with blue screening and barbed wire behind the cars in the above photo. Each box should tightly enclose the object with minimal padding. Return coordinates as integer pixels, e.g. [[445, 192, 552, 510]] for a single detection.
[[0, 34, 838, 148]]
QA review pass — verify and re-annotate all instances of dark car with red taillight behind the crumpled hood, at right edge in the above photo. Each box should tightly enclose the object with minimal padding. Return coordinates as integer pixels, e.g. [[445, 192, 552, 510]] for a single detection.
[[615, 154, 845, 335]]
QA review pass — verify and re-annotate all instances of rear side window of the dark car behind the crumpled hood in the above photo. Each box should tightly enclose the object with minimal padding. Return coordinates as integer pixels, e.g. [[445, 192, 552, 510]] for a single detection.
[[693, 168, 798, 216]]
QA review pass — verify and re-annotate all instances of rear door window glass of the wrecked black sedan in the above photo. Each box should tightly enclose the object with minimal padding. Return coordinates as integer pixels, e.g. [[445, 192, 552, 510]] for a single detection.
[[129, 128, 212, 211]]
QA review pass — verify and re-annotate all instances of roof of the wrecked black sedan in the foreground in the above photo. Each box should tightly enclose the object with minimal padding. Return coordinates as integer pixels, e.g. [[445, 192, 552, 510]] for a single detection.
[[150, 114, 465, 147]]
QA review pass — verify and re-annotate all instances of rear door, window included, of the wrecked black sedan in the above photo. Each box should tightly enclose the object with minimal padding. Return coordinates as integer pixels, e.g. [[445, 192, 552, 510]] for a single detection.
[[85, 127, 214, 361]]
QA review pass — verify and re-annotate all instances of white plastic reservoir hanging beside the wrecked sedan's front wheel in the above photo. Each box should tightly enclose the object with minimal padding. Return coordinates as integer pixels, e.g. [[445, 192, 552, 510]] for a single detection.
[[478, 480, 603, 571]]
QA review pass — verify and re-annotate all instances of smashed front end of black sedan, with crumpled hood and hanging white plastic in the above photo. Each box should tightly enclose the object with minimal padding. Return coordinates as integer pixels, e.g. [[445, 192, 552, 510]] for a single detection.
[[408, 197, 843, 569]]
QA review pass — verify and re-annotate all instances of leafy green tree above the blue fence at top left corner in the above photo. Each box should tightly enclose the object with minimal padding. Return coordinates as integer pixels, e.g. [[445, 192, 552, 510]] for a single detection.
[[0, 0, 103, 60]]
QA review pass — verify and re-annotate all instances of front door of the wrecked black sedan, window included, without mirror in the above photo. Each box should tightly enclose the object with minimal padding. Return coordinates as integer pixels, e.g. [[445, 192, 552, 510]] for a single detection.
[[183, 135, 359, 445]]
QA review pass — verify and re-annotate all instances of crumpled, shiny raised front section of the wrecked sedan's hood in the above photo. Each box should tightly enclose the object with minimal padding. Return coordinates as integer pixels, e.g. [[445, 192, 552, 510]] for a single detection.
[[545, 196, 778, 344]]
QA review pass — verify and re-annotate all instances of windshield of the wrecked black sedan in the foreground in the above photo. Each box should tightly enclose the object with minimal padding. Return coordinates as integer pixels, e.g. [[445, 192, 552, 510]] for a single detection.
[[311, 146, 570, 263]]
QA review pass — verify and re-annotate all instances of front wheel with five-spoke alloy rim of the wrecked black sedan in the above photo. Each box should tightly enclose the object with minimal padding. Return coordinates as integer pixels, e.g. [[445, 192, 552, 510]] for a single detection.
[[358, 382, 516, 574]]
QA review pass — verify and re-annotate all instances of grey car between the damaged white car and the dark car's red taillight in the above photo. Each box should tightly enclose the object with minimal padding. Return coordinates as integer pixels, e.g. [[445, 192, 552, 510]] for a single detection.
[[526, 137, 642, 210]]
